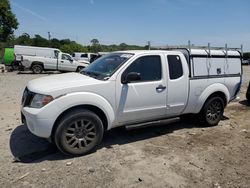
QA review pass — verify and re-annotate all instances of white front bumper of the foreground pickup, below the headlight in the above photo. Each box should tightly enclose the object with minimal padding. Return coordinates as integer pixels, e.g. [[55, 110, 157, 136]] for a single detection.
[[21, 107, 54, 138]]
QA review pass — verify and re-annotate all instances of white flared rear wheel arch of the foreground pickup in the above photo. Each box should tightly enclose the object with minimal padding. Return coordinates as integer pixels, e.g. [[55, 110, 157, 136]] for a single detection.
[[196, 83, 230, 113]]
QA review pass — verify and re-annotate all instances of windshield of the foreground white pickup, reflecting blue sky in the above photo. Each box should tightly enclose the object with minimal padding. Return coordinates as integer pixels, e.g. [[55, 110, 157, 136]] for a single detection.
[[80, 53, 133, 80]]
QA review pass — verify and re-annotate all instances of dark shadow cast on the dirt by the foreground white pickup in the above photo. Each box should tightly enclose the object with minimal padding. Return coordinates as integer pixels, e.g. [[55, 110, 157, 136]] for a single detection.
[[10, 121, 208, 163]]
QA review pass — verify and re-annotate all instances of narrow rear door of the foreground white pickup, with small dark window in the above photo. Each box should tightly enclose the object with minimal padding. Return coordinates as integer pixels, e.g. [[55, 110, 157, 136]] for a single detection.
[[166, 52, 189, 116]]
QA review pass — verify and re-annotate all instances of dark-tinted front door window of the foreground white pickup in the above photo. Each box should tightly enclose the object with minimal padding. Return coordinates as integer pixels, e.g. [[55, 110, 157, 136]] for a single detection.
[[122, 55, 162, 82]]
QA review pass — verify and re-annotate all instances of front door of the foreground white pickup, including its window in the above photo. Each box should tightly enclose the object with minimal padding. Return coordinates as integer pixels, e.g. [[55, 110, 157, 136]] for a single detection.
[[116, 54, 167, 124]]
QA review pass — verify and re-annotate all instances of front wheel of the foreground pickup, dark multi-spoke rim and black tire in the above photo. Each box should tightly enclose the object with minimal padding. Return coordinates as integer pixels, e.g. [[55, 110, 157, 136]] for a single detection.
[[54, 109, 104, 156]]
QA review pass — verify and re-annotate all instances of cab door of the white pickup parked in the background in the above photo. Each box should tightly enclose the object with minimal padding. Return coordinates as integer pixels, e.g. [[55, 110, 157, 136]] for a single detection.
[[58, 53, 76, 71]]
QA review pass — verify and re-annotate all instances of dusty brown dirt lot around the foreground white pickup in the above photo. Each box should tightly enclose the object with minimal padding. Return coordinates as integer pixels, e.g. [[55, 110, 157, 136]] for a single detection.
[[0, 66, 250, 188]]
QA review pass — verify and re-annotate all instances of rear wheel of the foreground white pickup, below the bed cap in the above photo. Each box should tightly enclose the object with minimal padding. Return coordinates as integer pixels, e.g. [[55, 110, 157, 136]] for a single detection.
[[200, 96, 225, 126]]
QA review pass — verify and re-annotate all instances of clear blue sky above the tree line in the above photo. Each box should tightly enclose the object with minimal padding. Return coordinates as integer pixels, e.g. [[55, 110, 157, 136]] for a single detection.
[[10, 0, 250, 51]]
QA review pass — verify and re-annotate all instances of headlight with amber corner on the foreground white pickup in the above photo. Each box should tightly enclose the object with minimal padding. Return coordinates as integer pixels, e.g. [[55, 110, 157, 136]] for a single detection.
[[29, 94, 53, 108]]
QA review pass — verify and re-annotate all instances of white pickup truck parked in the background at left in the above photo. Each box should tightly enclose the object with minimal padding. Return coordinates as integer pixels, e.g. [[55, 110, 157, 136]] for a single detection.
[[21, 52, 89, 74]]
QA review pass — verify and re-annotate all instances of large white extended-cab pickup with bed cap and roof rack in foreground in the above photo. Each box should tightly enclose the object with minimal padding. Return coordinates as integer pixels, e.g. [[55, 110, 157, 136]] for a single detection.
[[21, 49, 242, 155]]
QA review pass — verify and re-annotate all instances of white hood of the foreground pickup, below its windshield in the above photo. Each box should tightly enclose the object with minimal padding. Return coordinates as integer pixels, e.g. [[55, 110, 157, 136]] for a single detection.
[[27, 73, 102, 96]]
